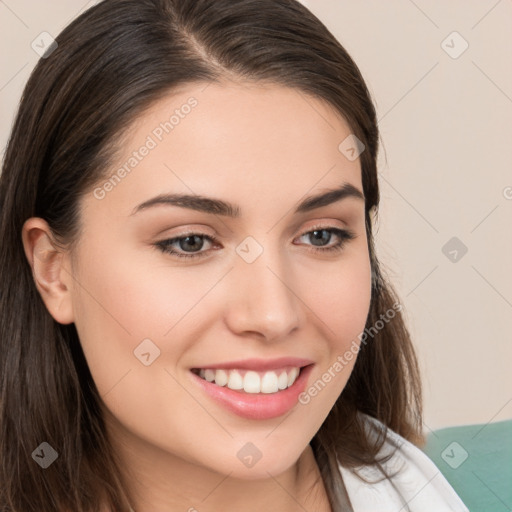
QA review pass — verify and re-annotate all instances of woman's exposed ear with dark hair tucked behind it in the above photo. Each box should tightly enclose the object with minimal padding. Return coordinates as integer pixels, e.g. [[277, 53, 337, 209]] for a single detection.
[[22, 217, 74, 324]]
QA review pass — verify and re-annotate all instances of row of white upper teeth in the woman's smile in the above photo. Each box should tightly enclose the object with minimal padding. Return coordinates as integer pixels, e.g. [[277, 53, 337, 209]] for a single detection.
[[199, 366, 300, 393]]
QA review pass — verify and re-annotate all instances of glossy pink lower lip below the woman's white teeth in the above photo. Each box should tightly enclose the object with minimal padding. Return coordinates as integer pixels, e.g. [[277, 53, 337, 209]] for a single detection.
[[190, 364, 313, 420]]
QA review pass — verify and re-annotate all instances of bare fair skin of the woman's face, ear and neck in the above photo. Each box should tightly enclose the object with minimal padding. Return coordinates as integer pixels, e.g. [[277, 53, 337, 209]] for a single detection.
[[22, 82, 371, 512]]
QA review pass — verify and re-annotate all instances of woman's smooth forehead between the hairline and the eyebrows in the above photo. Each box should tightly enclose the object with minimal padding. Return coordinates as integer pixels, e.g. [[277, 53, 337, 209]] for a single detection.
[[85, 83, 362, 220]]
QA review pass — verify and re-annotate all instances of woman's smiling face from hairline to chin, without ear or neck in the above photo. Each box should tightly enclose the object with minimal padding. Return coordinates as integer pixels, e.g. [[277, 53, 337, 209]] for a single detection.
[[62, 84, 371, 479]]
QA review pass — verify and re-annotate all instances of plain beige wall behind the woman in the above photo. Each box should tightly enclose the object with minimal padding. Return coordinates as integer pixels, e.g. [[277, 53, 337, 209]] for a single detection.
[[0, 0, 512, 429]]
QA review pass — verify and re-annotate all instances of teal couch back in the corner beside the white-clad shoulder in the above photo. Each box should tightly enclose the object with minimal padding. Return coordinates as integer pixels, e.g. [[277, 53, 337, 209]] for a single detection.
[[423, 420, 512, 512]]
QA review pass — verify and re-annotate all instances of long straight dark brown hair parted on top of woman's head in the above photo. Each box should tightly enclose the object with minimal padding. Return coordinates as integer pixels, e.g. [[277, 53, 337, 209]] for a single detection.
[[0, 0, 422, 512]]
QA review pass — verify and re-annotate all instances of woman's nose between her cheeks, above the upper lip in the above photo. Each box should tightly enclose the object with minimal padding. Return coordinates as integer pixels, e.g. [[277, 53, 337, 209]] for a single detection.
[[225, 250, 303, 341]]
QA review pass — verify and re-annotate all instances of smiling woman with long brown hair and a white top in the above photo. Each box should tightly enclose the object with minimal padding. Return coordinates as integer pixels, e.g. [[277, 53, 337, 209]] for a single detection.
[[0, 0, 467, 512]]
